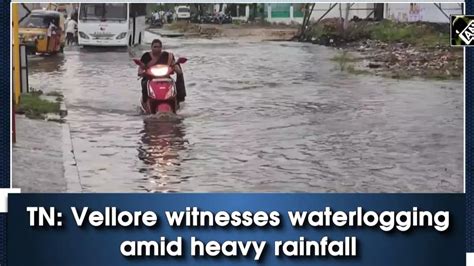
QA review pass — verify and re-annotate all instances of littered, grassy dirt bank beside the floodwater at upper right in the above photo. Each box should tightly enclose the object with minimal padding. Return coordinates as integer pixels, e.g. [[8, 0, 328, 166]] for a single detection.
[[303, 19, 464, 79]]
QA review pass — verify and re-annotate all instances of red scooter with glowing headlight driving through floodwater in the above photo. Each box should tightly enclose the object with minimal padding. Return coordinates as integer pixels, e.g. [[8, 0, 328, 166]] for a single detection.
[[133, 57, 188, 115]]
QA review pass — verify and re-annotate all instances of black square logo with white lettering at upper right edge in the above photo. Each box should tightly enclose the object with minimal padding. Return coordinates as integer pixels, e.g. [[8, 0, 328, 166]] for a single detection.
[[451, 15, 474, 46]]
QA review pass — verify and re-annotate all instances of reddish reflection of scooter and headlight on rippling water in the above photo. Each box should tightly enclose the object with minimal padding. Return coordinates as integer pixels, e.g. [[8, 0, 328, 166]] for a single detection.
[[138, 117, 186, 192]]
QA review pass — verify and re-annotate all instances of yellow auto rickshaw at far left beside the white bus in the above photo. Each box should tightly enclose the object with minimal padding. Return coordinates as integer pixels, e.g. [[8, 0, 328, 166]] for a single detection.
[[19, 10, 65, 54]]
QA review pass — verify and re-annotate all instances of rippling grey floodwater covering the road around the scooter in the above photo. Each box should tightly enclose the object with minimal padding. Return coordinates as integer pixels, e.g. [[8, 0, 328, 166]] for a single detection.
[[29, 33, 463, 192]]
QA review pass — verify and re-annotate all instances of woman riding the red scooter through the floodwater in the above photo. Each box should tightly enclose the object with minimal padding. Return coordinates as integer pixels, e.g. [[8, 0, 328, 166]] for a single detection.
[[138, 39, 186, 107]]
